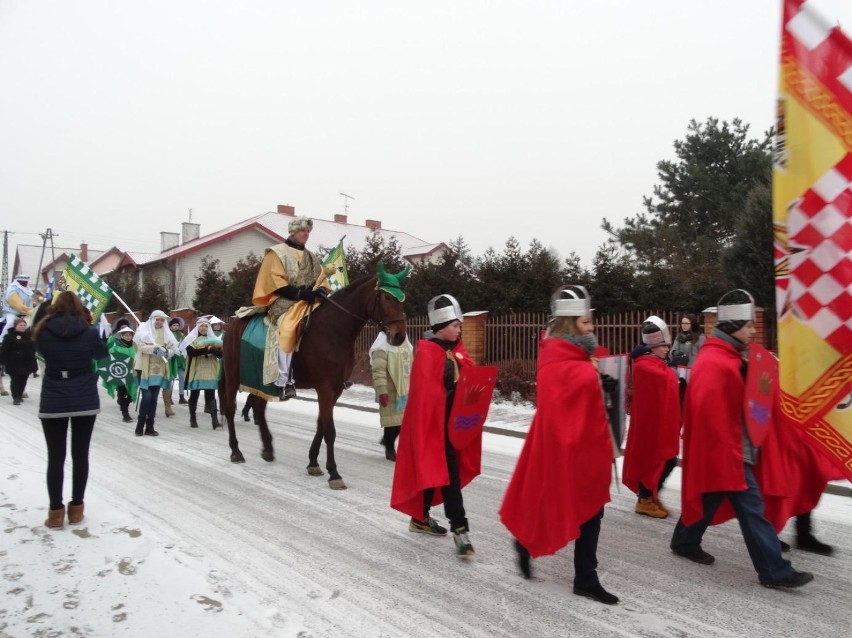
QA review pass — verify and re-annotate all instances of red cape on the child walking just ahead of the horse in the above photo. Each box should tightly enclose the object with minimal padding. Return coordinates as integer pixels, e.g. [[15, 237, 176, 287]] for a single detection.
[[391, 339, 482, 519]]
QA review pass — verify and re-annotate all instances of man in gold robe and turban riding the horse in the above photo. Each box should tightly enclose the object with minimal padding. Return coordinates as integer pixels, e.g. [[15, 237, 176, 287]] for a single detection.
[[252, 217, 330, 400]]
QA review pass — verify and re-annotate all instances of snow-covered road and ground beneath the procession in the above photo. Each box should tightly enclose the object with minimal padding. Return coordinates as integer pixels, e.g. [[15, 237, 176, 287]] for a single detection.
[[0, 380, 852, 638]]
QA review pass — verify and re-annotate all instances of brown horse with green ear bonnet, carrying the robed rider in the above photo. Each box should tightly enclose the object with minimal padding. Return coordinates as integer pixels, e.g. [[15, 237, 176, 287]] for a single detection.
[[223, 276, 406, 490]]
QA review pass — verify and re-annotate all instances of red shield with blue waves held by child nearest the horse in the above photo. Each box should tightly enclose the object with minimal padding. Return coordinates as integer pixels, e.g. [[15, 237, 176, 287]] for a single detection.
[[447, 366, 497, 450]]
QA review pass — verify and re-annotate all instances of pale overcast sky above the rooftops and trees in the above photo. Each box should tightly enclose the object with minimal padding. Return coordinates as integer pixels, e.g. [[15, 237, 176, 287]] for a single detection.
[[0, 0, 852, 275]]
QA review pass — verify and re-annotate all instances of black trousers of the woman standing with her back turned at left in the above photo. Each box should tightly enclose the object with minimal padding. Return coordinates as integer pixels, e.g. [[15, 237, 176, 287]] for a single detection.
[[41, 414, 97, 510]]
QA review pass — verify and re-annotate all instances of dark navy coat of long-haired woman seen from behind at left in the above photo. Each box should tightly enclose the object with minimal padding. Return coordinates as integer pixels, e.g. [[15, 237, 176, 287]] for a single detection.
[[36, 315, 109, 418]]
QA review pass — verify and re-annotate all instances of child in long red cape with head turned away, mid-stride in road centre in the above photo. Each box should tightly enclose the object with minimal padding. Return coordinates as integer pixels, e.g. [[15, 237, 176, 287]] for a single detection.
[[500, 286, 618, 605]]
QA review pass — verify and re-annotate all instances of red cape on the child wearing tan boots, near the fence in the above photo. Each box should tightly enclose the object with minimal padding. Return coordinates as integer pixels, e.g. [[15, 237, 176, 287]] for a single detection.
[[621, 355, 680, 498]]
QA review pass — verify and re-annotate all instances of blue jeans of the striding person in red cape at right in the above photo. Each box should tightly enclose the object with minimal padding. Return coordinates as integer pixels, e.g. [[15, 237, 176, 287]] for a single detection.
[[671, 465, 793, 583]]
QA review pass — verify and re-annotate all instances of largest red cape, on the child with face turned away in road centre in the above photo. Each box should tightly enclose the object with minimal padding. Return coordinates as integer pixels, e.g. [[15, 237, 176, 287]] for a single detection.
[[500, 338, 613, 557]]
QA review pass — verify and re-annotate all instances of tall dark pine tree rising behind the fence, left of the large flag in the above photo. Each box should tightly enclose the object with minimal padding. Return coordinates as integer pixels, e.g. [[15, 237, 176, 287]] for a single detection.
[[602, 118, 772, 308]]
